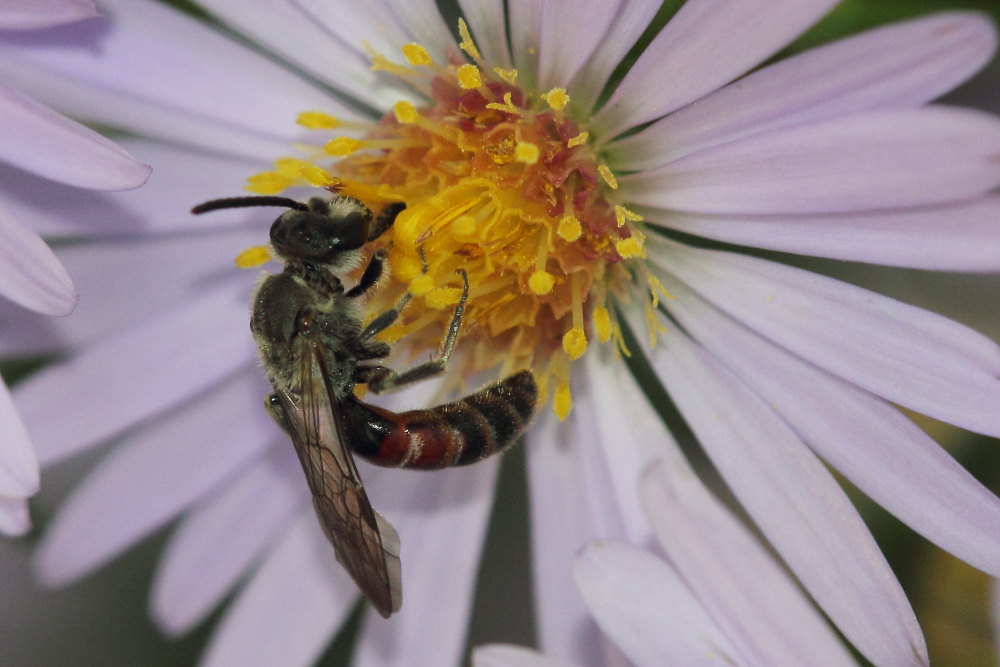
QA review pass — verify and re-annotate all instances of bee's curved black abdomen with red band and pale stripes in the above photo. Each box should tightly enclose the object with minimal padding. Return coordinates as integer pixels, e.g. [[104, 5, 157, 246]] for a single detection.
[[342, 371, 538, 468]]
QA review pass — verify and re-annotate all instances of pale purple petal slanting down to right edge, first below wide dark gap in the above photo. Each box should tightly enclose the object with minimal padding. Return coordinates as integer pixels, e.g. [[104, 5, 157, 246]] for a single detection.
[[661, 244, 1000, 435]]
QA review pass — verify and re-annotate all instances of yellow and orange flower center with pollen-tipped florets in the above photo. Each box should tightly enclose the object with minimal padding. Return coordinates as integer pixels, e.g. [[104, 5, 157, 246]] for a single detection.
[[241, 20, 656, 418]]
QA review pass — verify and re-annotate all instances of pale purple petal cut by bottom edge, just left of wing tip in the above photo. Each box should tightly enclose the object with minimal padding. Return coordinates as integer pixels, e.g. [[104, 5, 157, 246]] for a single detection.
[[201, 507, 357, 667]]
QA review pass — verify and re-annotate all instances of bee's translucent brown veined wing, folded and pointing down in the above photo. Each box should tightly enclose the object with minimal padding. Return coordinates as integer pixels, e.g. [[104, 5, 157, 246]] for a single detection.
[[277, 339, 402, 618]]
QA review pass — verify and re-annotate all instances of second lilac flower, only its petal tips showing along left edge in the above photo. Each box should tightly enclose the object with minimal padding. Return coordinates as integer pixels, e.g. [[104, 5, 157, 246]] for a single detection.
[[0, 0, 149, 535]]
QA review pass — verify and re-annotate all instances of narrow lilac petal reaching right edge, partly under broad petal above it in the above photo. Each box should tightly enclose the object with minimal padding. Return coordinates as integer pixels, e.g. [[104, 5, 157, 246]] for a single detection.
[[644, 196, 1000, 273]]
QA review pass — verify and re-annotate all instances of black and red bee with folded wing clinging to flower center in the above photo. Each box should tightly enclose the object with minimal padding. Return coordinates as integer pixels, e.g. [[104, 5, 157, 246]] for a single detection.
[[192, 195, 538, 618]]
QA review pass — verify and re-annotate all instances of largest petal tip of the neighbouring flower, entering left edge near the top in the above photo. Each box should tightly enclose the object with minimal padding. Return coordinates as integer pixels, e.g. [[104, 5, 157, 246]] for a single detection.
[[0, 83, 150, 190]]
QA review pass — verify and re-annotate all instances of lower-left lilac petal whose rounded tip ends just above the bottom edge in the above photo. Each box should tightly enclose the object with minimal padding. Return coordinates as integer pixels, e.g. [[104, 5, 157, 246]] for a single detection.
[[150, 442, 309, 635]]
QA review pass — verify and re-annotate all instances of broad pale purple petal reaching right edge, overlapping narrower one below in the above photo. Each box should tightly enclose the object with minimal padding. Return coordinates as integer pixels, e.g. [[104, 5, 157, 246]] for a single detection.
[[618, 107, 1000, 214]]
